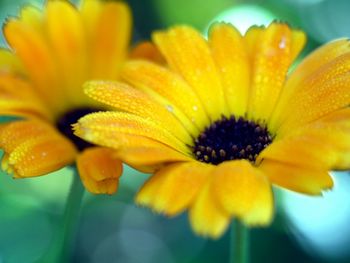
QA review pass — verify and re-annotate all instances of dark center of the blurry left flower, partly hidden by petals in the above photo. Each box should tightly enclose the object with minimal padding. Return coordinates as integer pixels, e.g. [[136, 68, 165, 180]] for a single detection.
[[56, 108, 99, 151]]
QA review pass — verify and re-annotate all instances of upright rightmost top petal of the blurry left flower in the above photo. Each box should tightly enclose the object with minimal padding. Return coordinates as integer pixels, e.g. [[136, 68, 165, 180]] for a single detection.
[[81, 0, 131, 79]]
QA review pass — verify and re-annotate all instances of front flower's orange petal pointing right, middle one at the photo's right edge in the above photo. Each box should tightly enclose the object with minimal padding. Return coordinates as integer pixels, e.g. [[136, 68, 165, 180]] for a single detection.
[[257, 108, 350, 179]]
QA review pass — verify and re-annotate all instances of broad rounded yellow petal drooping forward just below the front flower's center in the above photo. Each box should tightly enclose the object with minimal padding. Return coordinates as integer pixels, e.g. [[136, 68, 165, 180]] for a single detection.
[[213, 160, 274, 225]]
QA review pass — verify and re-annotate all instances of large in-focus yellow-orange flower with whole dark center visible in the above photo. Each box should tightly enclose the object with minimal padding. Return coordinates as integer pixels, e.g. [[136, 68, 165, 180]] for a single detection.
[[75, 23, 350, 238]]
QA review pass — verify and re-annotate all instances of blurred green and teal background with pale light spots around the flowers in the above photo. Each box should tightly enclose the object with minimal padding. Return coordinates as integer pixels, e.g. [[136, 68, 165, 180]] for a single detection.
[[0, 0, 350, 263]]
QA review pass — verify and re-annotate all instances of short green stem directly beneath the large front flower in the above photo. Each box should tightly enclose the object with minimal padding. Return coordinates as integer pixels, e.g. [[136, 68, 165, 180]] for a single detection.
[[230, 220, 249, 263]]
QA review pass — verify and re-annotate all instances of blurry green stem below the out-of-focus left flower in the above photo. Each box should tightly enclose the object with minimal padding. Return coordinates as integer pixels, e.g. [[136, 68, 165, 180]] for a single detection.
[[39, 168, 84, 263]]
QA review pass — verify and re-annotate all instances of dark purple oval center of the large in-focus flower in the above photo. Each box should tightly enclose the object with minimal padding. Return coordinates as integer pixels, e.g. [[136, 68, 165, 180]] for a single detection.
[[192, 116, 272, 164]]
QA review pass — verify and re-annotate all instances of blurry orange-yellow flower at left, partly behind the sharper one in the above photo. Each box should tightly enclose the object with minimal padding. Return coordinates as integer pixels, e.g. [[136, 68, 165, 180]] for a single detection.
[[0, 0, 137, 193]]
